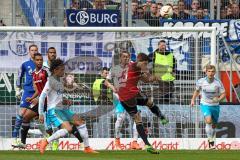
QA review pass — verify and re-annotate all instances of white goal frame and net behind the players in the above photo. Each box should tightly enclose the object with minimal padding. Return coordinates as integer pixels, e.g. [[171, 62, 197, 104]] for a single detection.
[[0, 27, 216, 138]]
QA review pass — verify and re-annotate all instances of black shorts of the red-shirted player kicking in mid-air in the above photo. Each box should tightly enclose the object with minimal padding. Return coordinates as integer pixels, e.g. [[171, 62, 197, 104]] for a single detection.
[[121, 94, 148, 116]]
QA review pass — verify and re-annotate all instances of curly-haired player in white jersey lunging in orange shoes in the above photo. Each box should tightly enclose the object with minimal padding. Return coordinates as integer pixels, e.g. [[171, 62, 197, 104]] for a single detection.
[[39, 59, 97, 154]]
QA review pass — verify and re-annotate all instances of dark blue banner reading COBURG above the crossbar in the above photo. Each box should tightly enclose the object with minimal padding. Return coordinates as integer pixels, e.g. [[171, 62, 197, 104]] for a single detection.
[[66, 9, 120, 27]]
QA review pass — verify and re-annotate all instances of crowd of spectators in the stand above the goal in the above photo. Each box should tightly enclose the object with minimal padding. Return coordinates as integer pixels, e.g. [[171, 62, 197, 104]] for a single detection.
[[66, 0, 240, 26]]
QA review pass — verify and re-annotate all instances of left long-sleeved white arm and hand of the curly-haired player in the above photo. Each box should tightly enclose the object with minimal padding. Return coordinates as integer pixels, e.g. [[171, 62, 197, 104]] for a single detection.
[[38, 81, 50, 123]]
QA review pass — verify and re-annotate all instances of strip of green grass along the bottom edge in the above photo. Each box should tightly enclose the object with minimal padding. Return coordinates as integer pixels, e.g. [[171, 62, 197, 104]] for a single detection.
[[0, 150, 240, 160]]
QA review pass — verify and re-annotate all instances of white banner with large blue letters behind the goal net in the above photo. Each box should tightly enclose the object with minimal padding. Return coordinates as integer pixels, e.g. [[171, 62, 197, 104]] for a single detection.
[[0, 32, 115, 74]]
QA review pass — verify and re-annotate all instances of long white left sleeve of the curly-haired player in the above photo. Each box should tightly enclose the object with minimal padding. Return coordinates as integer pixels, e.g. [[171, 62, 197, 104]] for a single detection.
[[38, 81, 50, 115]]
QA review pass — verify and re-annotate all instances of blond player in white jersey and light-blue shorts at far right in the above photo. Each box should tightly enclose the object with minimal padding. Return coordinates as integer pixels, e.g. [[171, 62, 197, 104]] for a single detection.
[[191, 65, 226, 149]]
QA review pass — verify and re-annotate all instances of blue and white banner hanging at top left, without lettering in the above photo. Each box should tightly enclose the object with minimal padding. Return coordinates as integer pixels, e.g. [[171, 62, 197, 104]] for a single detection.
[[19, 0, 45, 26]]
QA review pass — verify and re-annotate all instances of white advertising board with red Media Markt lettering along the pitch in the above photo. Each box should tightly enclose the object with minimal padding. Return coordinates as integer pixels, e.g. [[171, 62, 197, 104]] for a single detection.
[[0, 138, 240, 153]]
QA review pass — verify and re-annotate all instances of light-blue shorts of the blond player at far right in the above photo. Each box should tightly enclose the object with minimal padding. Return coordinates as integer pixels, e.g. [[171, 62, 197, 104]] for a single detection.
[[200, 104, 220, 124]]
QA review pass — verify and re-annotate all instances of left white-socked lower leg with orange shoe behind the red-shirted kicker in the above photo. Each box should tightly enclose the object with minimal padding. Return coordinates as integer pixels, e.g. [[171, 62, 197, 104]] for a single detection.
[[115, 112, 126, 150]]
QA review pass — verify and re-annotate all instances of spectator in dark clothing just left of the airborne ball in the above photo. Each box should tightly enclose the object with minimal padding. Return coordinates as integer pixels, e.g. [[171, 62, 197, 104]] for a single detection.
[[144, 3, 160, 26]]
